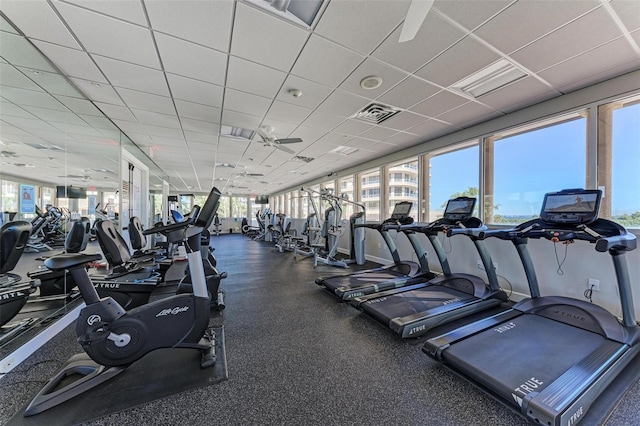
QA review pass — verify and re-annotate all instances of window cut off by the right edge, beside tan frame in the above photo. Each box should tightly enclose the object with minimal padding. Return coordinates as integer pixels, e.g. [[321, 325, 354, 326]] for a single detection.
[[597, 96, 640, 228]]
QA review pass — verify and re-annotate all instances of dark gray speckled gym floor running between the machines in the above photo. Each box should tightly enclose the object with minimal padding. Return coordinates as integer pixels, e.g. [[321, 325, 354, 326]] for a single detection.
[[0, 234, 640, 425]]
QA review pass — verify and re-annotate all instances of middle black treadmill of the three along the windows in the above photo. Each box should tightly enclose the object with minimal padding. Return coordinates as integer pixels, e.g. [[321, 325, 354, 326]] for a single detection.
[[350, 197, 508, 339]]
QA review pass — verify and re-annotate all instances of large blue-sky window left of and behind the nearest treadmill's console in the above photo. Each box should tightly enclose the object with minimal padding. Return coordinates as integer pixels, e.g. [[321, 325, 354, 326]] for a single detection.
[[484, 113, 587, 224]]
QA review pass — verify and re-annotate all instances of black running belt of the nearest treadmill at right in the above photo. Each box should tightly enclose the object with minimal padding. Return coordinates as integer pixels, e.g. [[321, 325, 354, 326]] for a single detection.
[[443, 314, 605, 404]]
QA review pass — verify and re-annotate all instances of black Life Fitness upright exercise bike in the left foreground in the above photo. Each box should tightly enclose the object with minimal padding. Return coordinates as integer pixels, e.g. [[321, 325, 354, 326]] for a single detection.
[[25, 188, 221, 416]]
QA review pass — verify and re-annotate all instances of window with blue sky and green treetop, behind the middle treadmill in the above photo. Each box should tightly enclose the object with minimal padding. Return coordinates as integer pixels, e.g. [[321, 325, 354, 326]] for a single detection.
[[426, 142, 480, 222]]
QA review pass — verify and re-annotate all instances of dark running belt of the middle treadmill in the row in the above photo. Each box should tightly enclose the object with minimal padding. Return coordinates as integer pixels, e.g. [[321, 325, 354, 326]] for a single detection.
[[361, 285, 475, 324]]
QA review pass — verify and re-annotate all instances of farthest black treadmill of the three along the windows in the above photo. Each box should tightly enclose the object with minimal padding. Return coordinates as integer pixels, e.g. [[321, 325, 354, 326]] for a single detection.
[[315, 201, 436, 300]]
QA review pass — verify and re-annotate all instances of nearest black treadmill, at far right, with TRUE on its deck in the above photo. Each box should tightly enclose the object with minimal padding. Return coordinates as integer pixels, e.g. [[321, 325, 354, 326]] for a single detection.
[[423, 189, 640, 426]]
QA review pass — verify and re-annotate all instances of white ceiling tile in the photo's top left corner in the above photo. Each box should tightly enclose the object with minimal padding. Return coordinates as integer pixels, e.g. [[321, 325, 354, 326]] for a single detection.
[[2, 1, 80, 49]]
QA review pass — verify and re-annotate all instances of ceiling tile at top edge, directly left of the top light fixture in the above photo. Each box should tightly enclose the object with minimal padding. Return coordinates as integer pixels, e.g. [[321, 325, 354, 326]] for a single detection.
[[145, 0, 234, 52]]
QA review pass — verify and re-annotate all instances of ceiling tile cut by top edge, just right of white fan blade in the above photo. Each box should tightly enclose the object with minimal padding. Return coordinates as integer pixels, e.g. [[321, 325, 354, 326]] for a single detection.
[[433, 0, 512, 30]]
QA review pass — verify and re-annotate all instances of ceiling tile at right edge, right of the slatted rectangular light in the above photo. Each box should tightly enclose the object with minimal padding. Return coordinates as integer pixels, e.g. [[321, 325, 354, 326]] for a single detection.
[[539, 38, 640, 92]]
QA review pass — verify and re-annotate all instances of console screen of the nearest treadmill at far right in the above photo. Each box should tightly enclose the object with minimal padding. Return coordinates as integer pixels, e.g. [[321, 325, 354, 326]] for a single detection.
[[540, 189, 602, 224]]
